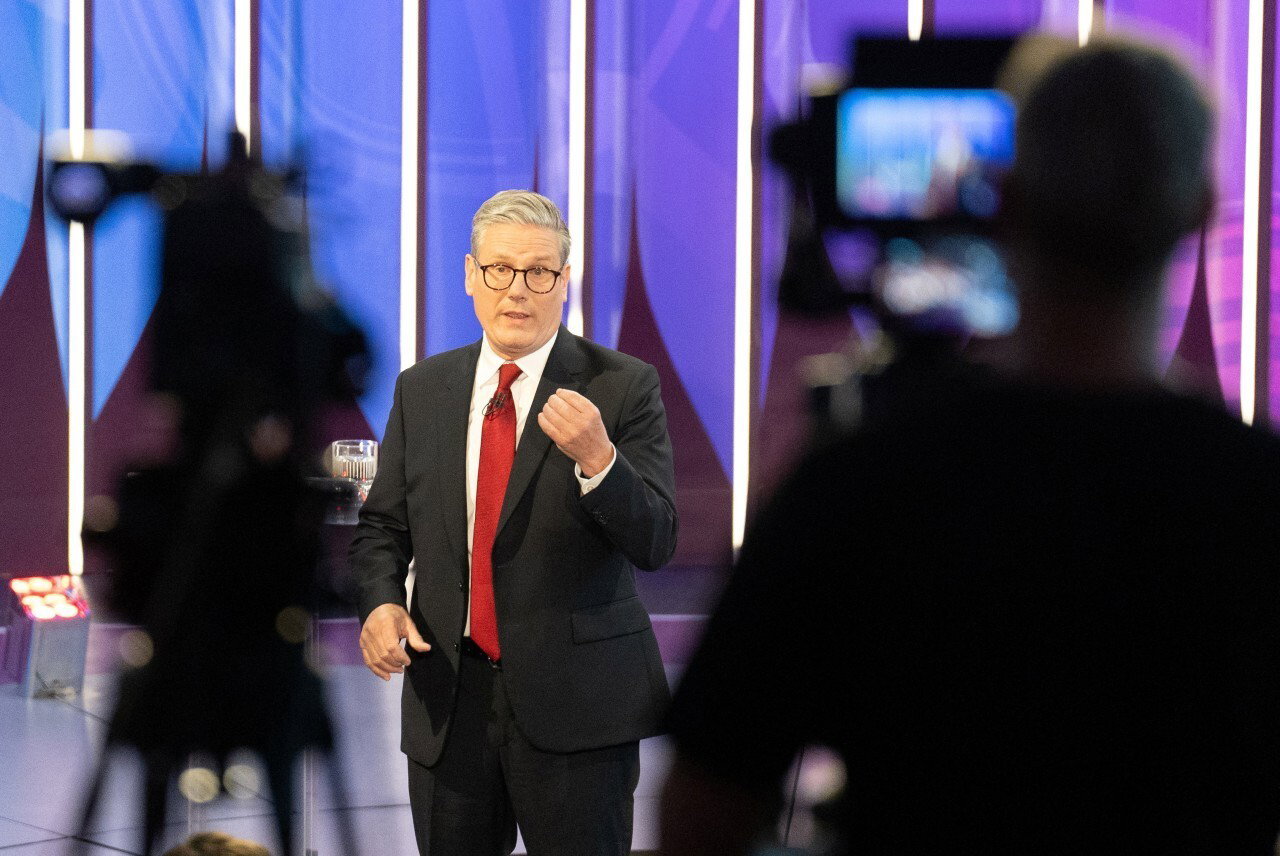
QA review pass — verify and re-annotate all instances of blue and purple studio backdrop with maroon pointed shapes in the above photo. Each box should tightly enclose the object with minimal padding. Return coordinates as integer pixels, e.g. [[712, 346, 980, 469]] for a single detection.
[[0, 0, 1280, 613]]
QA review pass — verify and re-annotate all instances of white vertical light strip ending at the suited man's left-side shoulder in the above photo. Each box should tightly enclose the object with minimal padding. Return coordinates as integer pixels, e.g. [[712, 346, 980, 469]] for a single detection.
[[401, 0, 421, 369]]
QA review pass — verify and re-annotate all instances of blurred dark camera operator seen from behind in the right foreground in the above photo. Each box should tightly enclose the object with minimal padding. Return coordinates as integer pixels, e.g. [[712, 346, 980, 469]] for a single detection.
[[662, 33, 1280, 856]]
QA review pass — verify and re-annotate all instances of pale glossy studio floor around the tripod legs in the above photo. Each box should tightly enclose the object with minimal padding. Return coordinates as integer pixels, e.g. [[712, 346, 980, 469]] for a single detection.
[[0, 639, 676, 856]]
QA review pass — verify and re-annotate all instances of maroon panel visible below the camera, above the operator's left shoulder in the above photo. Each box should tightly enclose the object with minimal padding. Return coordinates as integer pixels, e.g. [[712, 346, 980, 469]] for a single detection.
[[748, 312, 852, 518]]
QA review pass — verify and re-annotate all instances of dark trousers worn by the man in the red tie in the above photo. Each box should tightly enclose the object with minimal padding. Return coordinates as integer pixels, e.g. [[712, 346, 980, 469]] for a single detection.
[[408, 644, 640, 856]]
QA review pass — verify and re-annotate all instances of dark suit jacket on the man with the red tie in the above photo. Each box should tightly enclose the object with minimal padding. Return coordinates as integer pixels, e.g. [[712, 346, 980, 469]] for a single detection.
[[351, 328, 676, 766]]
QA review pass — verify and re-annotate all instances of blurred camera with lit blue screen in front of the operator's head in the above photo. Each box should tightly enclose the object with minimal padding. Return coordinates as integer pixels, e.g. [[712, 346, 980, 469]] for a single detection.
[[772, 37, 1016, 337]]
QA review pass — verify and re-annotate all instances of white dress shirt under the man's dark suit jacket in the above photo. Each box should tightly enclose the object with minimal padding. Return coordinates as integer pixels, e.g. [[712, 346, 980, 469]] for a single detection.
[[462, 333, 618, 636]]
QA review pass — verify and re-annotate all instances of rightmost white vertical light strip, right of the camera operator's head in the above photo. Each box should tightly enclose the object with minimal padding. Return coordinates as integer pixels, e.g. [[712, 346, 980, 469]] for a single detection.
[[1240, 0, 1266, 425]]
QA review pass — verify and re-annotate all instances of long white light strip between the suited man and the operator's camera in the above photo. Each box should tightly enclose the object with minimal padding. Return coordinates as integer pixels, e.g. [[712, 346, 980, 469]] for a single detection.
[[732, 0, 756, 550]]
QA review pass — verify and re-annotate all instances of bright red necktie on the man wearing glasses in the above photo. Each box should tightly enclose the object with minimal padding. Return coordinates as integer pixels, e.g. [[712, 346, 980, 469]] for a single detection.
[[471, 362, 520, 660]]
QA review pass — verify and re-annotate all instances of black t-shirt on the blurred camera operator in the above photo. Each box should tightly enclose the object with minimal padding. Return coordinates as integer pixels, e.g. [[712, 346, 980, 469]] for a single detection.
[[669, 383, 1280, 856]]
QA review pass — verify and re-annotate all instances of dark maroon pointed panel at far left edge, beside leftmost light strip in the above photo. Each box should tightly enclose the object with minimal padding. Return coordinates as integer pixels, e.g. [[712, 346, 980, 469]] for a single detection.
[[0, 149, 67, 576]]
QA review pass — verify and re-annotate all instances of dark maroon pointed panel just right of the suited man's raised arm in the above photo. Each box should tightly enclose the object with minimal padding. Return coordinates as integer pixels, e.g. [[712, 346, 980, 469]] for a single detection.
[[618, 201, 733, 567]]
